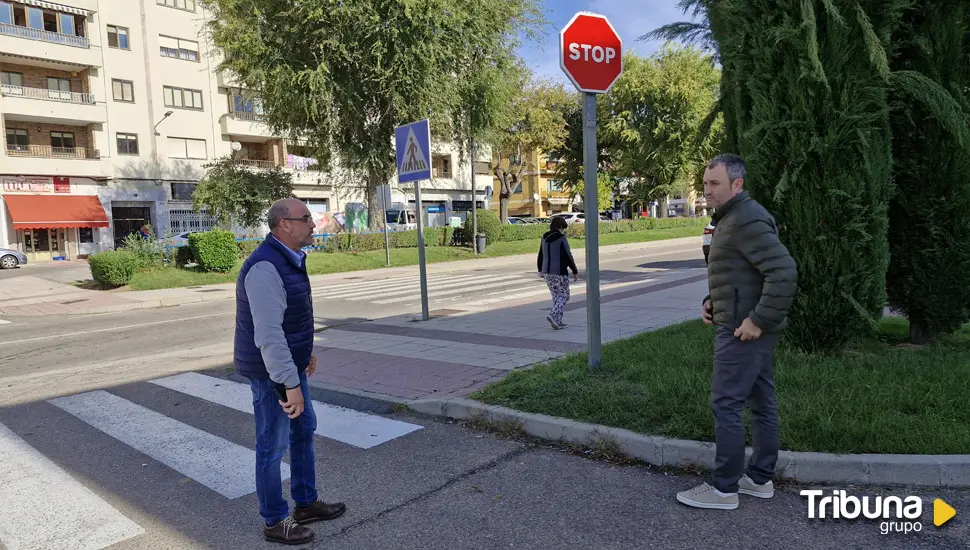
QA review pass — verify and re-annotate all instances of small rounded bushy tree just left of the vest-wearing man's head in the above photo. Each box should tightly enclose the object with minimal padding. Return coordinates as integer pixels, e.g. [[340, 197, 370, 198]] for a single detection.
[[192, 157, 293, 227]]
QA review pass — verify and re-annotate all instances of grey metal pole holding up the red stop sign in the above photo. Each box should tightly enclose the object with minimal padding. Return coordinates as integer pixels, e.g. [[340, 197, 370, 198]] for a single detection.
[[583, 92, 602, 370]]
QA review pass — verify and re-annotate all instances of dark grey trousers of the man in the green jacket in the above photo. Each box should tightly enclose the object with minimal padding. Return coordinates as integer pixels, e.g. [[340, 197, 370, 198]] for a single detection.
[[710, 327, 779, 493]]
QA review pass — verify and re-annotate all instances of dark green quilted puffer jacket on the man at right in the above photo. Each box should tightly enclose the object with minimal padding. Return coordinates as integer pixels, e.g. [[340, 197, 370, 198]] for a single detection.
[[704, 191, 798, 334]]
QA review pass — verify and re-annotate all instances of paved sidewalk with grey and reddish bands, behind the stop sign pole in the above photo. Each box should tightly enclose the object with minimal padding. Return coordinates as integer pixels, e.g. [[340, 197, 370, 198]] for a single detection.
[[311, 269, 707, 402]]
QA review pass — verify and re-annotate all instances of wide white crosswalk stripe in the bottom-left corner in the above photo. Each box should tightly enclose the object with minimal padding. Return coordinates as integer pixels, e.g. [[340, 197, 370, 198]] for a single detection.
[[0, 424, 145, 550]]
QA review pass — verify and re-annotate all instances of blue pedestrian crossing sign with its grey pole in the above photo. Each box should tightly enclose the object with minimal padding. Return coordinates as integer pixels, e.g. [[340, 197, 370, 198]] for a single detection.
[[394, 119, 431, 321]]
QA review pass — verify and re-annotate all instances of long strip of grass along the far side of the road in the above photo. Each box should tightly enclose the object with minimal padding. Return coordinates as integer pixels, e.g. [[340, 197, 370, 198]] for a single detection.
[[128, 225, 703, 290]]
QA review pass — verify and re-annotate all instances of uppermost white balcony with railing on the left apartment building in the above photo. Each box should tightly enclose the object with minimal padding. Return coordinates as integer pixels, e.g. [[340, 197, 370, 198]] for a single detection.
[[0, 23, 101, 67]]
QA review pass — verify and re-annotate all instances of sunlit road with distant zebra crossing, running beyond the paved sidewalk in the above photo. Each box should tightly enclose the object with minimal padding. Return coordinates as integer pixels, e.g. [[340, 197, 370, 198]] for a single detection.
[[0, 245, 703, 382]]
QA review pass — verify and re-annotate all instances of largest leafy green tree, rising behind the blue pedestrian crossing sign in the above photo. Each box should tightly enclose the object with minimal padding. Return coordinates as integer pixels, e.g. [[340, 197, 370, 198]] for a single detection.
[[202, 0, 543, 229]]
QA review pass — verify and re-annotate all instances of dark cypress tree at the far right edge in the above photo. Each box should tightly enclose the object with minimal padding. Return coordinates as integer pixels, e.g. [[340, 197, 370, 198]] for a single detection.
[[887, 0, 970, 343]]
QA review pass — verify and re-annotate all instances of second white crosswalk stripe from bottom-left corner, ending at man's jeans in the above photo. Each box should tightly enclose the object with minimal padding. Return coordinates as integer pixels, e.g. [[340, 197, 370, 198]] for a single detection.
[[49, 390, 290, 499]]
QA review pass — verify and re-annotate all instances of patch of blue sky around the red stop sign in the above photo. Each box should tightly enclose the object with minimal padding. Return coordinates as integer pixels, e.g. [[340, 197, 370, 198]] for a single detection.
[[519, 0, 689, 82]]
